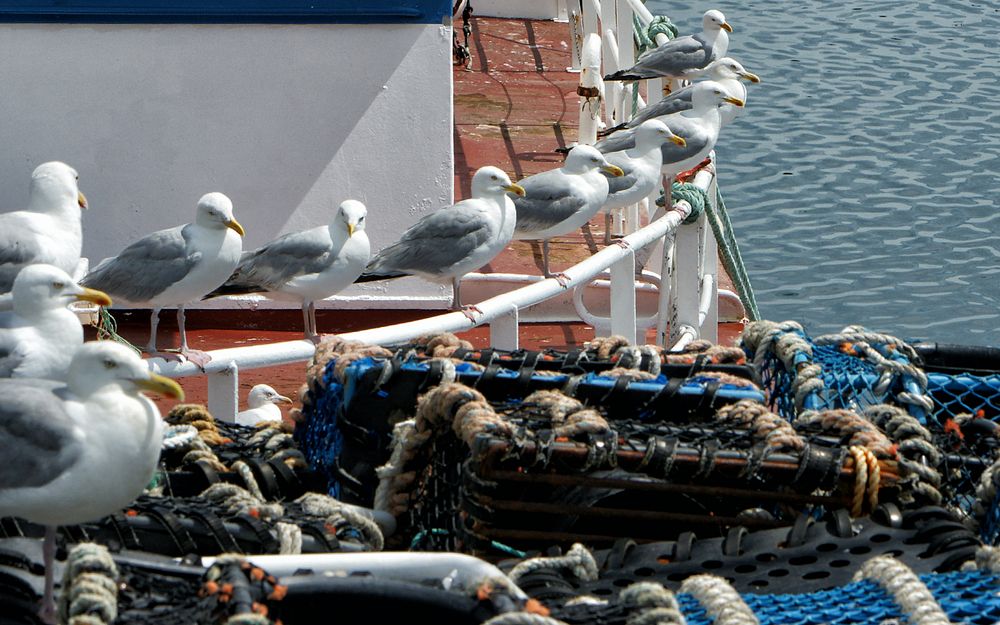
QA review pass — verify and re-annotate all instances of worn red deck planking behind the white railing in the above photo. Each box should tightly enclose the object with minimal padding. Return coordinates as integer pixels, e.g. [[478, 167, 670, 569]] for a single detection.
[[116, 18, 742, 409]]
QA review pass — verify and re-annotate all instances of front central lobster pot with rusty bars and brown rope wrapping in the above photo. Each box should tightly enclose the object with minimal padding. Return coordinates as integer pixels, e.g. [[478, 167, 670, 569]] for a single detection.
[[398, 398, 897, 557]]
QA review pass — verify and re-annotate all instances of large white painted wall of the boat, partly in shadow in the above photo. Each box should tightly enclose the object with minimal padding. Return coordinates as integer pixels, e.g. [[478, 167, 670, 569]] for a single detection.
[[0, 23, 454, 308]]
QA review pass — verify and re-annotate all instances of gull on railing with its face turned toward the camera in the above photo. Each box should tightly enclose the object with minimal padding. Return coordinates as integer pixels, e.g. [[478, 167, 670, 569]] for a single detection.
[[205, 200, 371, 339]]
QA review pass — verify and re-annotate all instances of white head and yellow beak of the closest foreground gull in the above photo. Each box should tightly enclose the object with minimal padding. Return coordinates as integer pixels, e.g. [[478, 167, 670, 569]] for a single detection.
[[69, 341, 184, 401]]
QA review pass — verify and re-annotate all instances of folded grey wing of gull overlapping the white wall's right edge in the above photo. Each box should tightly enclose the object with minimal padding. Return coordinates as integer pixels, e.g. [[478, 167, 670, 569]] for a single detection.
[[365, 200, 490, 275]]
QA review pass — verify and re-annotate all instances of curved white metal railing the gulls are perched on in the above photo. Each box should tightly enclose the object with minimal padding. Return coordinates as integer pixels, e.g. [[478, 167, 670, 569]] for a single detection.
[[148, 0, 718, 420]]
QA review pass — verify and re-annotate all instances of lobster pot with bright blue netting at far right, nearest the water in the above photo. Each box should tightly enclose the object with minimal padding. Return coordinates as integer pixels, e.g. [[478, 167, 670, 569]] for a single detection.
[[742, 322, 1000, 528]]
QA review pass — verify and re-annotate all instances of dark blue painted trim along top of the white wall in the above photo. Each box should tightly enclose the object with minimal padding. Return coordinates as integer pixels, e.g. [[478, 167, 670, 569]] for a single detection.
[[0, 0, 451, 24]]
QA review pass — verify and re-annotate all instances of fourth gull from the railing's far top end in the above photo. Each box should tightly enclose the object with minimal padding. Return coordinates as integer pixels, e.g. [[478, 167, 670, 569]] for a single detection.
[[602, 119, 685, 244]]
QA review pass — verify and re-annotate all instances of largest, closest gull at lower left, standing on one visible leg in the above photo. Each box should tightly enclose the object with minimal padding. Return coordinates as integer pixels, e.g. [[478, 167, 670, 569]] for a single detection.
[[0, 341, 184, 623]]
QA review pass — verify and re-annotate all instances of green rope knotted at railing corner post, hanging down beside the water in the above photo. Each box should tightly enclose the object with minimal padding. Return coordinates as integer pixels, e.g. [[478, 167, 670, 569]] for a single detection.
[[656, 182, 760, 321]]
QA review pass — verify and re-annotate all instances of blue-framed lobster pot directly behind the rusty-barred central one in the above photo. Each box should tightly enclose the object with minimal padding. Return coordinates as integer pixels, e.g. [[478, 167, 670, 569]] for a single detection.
[[295, 335, 764, 506]]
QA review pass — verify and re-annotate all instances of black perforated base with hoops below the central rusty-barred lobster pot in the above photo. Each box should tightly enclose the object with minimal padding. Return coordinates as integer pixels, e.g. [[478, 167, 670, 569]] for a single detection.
[[516, 504, 980, 604]]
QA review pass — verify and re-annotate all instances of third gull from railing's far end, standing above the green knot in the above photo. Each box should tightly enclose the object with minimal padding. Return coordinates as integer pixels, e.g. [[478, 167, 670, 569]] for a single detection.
[[596, 80, 743, 216]]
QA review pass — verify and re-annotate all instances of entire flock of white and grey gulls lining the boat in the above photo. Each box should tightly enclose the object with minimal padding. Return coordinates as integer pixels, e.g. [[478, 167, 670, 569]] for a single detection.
[[0, 10, 759, 620]]
